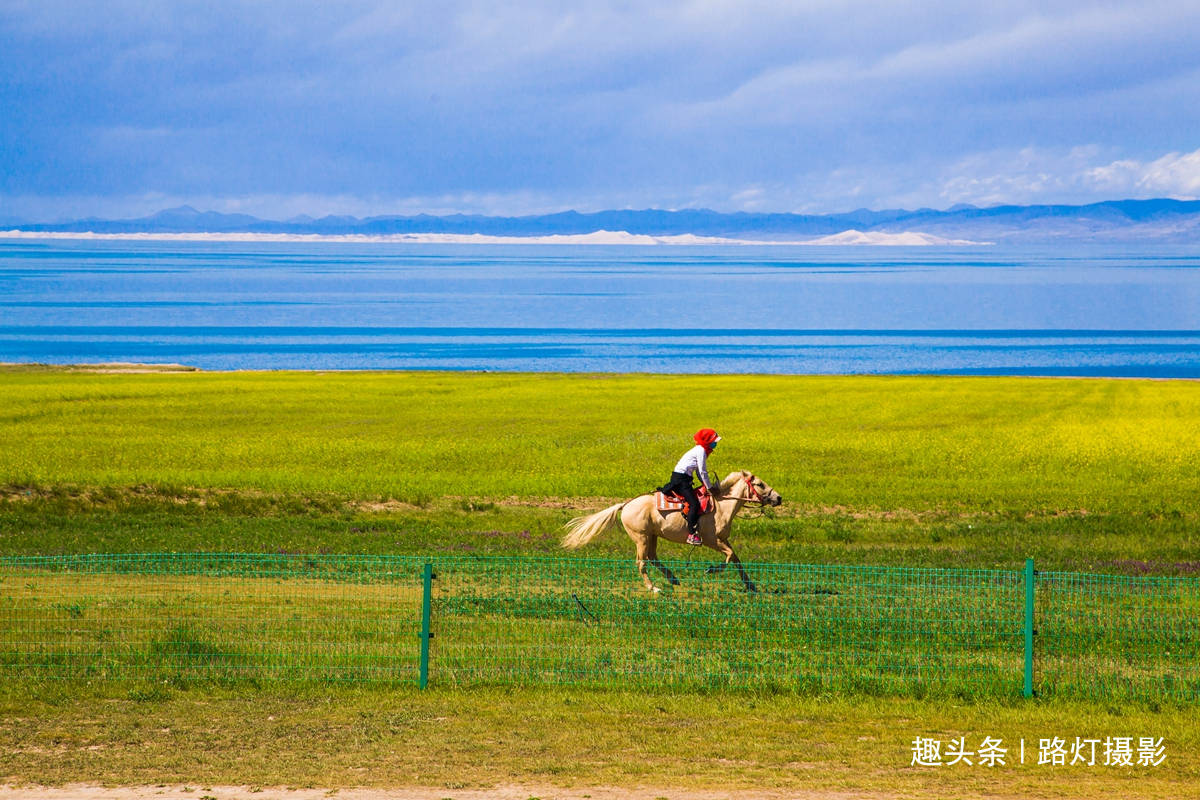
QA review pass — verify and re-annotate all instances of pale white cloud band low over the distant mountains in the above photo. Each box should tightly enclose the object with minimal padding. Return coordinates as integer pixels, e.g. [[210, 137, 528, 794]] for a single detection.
[[0, 145, 1200, 222]]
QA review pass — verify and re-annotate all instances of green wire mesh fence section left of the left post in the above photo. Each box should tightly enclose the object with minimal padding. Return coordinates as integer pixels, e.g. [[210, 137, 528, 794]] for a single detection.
[[0, 553, 422, 682]]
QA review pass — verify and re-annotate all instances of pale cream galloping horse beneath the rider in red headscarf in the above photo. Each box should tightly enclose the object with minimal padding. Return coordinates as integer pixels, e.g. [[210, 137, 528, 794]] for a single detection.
[[563, 471, 784, 593]]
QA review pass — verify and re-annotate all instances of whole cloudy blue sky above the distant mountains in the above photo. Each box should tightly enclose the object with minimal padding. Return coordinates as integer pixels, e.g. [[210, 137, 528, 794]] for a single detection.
[[0, 0, 1200, 222]]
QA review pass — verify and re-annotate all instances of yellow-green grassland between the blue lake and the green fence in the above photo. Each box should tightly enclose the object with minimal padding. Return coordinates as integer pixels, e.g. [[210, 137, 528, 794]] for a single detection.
[[0, 368, 1200, 575]]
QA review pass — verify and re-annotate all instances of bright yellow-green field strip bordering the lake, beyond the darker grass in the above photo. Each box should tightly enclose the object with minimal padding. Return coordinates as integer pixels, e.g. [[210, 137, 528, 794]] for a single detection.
[[0, 372, 1200, 513]]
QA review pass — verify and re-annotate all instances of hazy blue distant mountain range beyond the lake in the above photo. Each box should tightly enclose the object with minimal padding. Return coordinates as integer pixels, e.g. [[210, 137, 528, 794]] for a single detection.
[[6, 199, 1200, 243]]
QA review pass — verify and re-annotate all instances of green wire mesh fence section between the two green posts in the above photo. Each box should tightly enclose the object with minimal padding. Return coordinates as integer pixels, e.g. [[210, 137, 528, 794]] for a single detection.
[[432, 559, 1022, 693]]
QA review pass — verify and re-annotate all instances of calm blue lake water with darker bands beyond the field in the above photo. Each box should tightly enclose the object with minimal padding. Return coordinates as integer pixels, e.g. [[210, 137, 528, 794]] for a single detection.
[[0, 240, 1200, 378]]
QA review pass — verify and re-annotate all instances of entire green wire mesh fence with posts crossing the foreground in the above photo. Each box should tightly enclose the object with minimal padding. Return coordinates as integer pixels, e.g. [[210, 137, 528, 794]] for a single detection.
[[0, 554, 1200, 702]]
